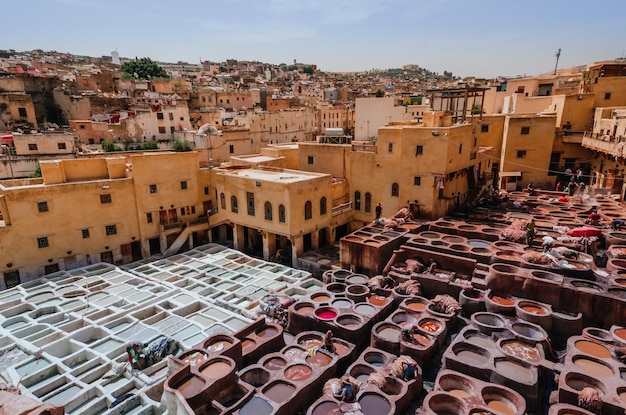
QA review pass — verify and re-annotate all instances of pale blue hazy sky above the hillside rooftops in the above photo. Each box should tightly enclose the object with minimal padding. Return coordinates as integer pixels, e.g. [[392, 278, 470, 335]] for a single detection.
[[0, 0, 626, 78]]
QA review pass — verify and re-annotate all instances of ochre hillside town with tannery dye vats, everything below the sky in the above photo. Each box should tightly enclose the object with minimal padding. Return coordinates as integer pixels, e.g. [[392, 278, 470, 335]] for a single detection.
[[0, 50, 626, 415]]
